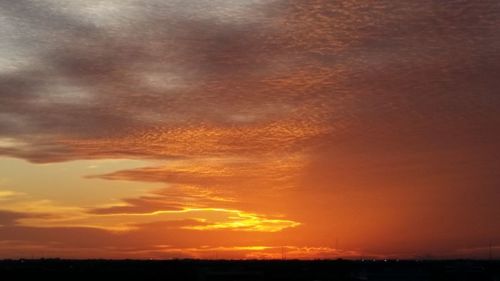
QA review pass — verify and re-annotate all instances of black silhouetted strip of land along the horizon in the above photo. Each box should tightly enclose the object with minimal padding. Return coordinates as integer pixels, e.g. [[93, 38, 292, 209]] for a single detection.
[[0, 259, 500, 281]]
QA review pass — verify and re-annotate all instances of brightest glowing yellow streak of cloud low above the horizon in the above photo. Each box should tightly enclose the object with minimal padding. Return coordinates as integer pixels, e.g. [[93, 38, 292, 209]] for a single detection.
[[62, 203, 300, 232]]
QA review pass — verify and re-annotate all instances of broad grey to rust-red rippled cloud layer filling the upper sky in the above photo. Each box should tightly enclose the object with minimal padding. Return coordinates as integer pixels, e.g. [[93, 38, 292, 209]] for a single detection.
[[0, 0, 500, 162]]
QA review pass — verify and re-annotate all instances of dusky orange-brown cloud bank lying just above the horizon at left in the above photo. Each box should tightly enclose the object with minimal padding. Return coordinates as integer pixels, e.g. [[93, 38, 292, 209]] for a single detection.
[[0, 214, 300, 258]]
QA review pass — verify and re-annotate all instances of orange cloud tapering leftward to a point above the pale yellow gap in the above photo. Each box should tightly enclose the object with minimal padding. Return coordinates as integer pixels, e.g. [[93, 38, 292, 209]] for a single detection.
[[88, 154, 304, 189]]
